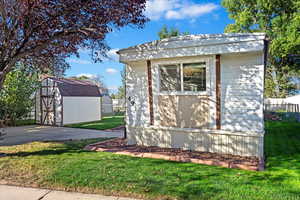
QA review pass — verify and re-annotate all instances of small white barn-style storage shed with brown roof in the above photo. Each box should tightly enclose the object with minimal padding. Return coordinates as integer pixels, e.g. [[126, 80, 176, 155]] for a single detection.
[[35, 77, 101, 126]]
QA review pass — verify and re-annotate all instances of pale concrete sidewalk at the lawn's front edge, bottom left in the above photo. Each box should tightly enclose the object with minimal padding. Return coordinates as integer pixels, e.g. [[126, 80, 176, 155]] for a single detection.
[[0, 185, 134, 200]]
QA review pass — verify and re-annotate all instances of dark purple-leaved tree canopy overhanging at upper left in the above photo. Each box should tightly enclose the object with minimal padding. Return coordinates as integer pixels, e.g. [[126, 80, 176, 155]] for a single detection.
[[0, 0, 147, 88]]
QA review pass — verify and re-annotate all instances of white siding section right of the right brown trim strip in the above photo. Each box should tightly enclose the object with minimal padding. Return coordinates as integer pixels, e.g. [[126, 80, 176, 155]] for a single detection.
[[221, 52, 264, 132]]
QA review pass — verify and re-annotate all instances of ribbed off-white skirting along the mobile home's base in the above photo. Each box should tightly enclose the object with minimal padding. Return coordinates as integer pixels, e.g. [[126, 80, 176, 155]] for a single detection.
[[127, 127, 263, 158]]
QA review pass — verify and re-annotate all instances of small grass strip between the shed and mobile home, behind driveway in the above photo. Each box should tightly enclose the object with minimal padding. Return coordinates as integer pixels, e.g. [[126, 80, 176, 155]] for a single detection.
[[66, 116, 124, 130]]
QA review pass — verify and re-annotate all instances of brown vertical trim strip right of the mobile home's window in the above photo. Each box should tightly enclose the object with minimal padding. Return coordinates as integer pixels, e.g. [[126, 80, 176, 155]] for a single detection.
[[216, 55, 221, 130]]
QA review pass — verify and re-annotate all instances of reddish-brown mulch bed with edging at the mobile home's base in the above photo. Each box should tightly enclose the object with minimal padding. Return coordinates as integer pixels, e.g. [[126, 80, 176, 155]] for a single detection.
[[84, 138, 264, 171]]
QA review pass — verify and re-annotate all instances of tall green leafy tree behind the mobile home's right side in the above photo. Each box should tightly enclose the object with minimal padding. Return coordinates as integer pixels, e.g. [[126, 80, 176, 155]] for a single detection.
[[222, 0, 300, 97]]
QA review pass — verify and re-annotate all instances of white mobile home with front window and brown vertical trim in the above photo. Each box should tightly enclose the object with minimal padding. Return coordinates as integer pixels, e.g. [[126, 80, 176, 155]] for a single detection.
[[118, 33, 266, 161]]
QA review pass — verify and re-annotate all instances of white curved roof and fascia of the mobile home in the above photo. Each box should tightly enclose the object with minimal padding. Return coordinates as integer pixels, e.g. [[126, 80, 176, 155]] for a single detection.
[[117, 33, 266, 62]]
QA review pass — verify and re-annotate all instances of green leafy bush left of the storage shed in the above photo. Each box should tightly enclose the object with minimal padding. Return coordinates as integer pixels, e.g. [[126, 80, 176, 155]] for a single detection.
[[0, 65, 39, 124]]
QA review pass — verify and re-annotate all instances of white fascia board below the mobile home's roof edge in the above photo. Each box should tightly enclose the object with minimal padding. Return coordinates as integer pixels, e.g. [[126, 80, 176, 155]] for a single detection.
[[119, 39, 264, 63]]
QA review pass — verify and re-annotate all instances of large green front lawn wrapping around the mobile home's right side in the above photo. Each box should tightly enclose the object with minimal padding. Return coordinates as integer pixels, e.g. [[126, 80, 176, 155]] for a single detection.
[[0, 122, 300, 200]]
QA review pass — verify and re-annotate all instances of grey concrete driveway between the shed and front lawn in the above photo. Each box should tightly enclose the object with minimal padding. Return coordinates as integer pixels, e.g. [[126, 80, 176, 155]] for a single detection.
[[0, 125, 124, 146]]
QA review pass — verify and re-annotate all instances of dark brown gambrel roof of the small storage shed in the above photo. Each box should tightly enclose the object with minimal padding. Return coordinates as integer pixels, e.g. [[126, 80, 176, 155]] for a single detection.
[[49, 77, 101, 97]]
